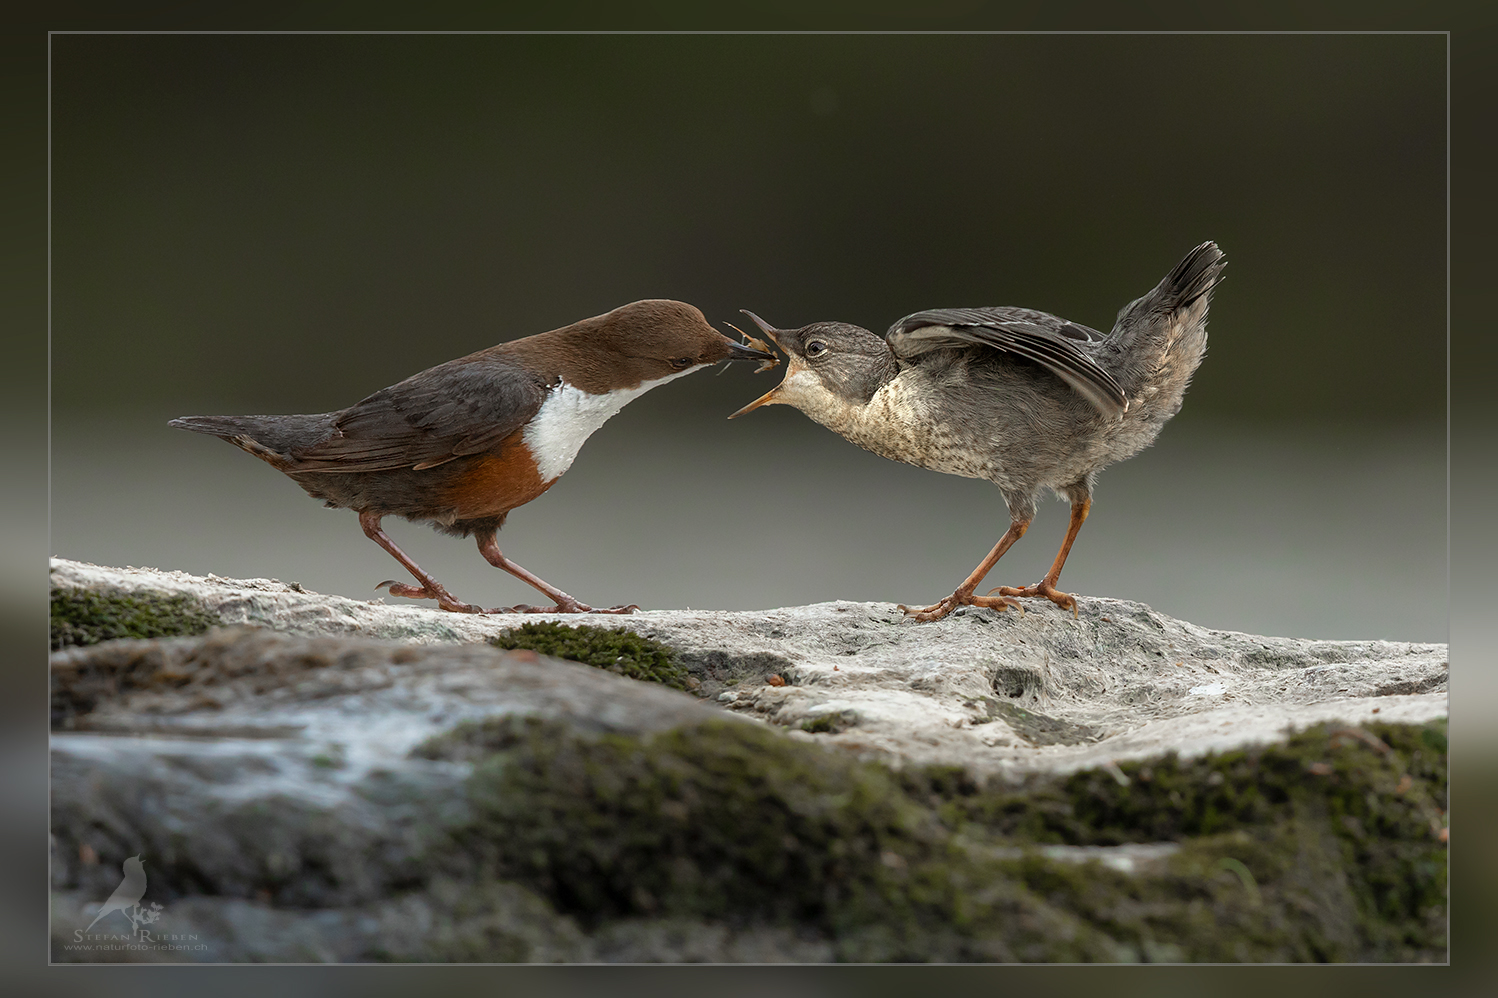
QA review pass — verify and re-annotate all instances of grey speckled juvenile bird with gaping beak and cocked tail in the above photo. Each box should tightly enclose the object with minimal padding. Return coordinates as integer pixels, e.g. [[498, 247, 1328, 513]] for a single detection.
[[730, 243, 1227, 620]]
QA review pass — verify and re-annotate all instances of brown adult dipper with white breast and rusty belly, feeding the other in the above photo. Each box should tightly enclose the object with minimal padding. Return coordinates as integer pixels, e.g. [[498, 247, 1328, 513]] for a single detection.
[[169, 300, 774, 613]]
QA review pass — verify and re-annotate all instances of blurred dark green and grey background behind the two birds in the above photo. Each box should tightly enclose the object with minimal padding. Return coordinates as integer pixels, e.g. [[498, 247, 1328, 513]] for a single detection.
[[51, 34, 1447, 640]]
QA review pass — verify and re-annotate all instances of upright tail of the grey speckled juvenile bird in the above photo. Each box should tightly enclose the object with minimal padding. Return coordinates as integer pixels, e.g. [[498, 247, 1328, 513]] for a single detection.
[[1106, 241, 1227, 421]]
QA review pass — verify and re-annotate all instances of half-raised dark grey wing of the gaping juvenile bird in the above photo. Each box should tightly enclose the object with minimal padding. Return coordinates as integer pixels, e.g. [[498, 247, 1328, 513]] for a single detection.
[[884, 307, 1128, 415]]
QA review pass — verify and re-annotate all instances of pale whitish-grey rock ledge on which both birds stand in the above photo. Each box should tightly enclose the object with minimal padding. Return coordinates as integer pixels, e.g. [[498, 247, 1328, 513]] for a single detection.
[[52, 559, 1449, 772]]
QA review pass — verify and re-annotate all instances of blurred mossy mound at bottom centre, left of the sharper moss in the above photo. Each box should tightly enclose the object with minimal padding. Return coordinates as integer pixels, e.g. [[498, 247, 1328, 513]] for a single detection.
[[443, 710, 1115, 961]]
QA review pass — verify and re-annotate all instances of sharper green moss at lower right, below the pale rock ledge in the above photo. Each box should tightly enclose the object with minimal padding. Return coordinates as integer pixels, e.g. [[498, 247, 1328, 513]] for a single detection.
[[905, 721, 1447, 961]]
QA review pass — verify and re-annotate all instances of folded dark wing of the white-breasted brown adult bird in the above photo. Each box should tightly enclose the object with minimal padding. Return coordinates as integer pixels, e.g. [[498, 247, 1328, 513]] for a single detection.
[[288, 358, 547, 472]]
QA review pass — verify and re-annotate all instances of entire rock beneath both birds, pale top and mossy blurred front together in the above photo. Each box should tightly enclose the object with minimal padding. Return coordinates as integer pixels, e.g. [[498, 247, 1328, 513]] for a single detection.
[[51, 559, 1447, 962]]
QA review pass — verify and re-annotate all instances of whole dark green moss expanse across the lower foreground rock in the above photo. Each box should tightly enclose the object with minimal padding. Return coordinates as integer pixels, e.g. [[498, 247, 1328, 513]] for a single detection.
[[428, 719, 1446, 962]]
